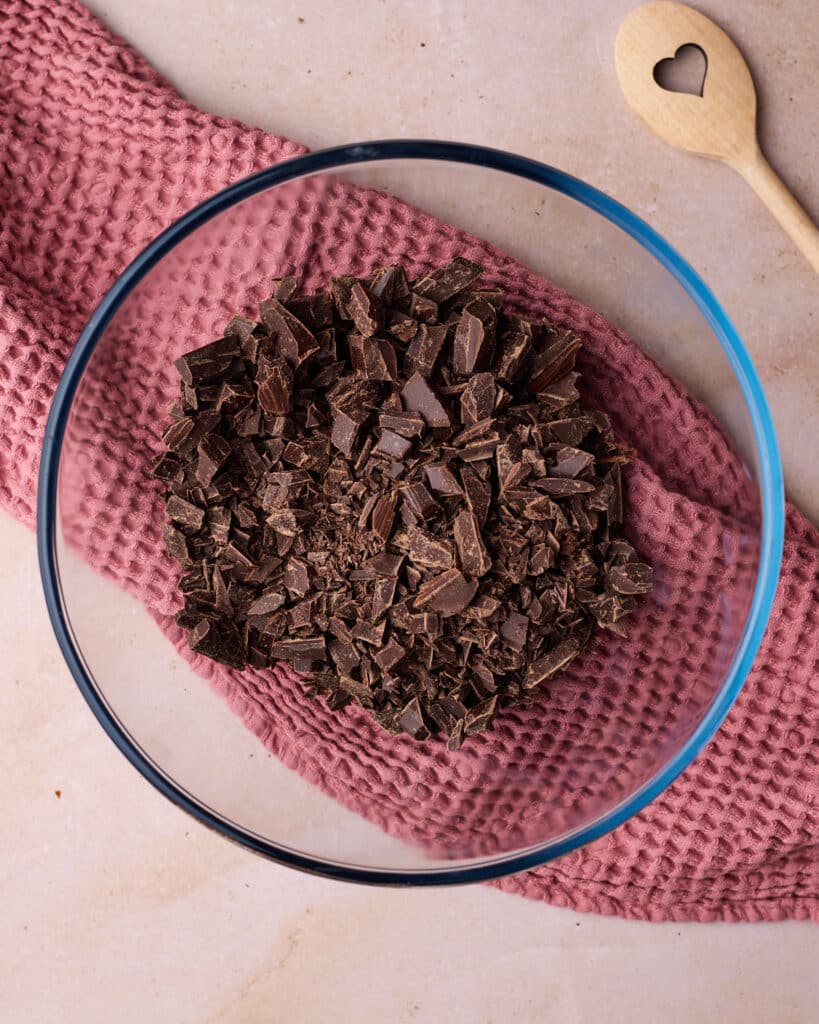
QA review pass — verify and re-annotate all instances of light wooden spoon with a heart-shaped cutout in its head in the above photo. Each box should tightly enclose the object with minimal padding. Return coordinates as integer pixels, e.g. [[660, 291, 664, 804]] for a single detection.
[[614, 0, 819, 273]]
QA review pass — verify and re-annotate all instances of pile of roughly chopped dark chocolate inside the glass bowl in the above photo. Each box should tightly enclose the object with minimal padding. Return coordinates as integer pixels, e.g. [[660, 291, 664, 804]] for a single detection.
[[154, 258, 651, 749]]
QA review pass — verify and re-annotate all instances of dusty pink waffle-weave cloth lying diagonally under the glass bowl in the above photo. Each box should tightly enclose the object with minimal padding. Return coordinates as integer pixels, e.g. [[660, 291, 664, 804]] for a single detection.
[[0, 0, 819, 921]]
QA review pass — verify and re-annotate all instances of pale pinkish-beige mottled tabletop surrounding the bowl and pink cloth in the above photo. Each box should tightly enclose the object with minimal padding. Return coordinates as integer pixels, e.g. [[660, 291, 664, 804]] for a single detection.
[[0, 0, 819, 1024]]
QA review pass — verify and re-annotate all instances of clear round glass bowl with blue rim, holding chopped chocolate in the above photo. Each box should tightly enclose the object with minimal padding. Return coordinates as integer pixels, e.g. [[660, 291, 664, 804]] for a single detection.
[[38, 141, 784, 885]]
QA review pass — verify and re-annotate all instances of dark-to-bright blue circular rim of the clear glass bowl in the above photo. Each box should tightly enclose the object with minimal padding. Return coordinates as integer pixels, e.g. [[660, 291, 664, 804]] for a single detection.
[[37, 139, 785, 886]]
